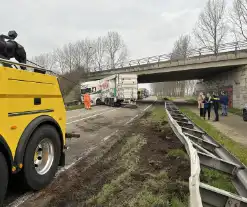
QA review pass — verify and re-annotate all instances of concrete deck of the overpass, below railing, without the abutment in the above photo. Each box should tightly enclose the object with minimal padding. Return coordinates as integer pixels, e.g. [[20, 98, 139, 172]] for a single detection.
[[88, 50, 247, 83]]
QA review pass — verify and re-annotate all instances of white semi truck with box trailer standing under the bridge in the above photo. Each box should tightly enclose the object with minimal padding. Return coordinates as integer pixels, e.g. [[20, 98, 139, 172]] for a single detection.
[[81, 74, 138, 106]]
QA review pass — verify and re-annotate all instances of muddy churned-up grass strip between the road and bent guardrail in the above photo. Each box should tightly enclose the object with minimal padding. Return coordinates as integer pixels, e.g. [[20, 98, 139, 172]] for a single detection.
[[21, 106, 190, 207]]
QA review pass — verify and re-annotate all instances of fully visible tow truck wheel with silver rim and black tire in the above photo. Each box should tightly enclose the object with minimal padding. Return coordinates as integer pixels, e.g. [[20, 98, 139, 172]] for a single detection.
[[23, 125, 61, 190]]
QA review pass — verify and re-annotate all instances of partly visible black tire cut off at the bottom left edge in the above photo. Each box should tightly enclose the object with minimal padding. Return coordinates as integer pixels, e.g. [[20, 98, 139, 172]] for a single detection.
[[0, 152, 9, 206]]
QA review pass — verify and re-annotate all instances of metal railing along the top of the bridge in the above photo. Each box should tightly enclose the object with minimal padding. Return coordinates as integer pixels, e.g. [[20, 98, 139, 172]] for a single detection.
[[91, 41, 247, 72]]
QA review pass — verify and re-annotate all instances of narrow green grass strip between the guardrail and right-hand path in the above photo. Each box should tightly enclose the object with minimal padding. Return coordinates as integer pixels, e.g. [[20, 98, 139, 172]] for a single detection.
[[180, 107, 247, 165]]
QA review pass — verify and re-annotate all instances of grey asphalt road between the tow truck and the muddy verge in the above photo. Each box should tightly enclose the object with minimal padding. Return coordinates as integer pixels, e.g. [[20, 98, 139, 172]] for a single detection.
[[5, 97, 156, 207]]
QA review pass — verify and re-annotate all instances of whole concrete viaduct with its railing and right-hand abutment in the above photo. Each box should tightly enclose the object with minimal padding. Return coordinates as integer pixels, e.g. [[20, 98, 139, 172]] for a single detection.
[[69, 42, 247, 108]]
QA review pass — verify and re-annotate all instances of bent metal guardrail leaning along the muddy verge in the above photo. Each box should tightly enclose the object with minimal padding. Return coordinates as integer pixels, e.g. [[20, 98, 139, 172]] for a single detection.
[[165, 102, 247, 207]]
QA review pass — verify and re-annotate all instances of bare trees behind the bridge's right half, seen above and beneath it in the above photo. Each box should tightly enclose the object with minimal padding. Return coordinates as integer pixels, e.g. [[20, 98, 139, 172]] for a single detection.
[[152, 0, 247, 96]]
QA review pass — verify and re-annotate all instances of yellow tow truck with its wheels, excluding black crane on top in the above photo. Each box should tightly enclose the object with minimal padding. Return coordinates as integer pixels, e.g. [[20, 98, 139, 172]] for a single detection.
[[0, 31, 71, 206]]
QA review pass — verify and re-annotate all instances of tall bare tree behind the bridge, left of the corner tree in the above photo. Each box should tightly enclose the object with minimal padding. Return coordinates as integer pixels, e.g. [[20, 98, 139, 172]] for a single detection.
[[194, 0, 228, 55]]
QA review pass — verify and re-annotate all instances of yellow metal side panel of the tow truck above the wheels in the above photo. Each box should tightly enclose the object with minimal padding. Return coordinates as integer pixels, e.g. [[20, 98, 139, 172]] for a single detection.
[[0, 66, 66, 157]]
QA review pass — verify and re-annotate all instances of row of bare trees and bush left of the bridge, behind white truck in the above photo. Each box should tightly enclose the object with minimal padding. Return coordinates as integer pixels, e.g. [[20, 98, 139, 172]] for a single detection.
[[32, 31, 128, 95]]
